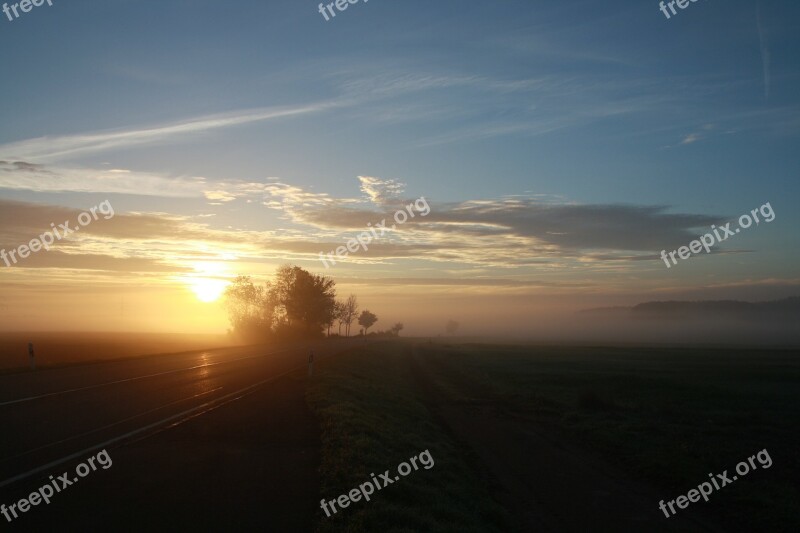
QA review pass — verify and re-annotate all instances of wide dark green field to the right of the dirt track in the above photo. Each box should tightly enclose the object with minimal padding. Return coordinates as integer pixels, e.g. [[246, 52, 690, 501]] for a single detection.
[[421, 345, 800, 531]]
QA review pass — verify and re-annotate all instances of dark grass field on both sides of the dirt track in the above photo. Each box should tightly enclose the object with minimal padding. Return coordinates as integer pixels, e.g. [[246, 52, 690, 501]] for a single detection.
[[308, 343, 800, 531]]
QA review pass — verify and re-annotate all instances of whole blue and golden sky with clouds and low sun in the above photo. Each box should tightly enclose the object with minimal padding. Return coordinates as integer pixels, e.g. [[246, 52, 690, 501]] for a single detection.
[[0, 0, 800, 335]]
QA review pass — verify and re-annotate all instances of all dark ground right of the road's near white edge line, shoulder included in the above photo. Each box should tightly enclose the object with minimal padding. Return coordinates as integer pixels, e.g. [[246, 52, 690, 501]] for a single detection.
[[0, 341, 800, 532]]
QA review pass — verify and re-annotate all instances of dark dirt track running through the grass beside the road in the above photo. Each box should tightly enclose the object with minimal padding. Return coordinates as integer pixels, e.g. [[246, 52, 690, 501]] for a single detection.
[[408, 349, 716, 532]]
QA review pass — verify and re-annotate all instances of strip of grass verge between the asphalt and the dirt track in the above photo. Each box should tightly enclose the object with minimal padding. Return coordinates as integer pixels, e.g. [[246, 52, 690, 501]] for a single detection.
[[306, 342, 511, 533]]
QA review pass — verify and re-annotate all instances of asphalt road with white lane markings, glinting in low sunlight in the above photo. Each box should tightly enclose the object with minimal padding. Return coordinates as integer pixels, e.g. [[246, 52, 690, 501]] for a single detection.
[[0, 339, 363, 492]]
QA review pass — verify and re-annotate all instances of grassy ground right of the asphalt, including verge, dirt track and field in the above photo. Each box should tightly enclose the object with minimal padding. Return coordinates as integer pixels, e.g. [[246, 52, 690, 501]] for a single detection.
[[309, 343, 800, 531]]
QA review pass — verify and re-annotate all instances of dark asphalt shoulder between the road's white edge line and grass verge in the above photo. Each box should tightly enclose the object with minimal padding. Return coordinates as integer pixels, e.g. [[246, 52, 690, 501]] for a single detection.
[[0, 376, 320, 531]]
